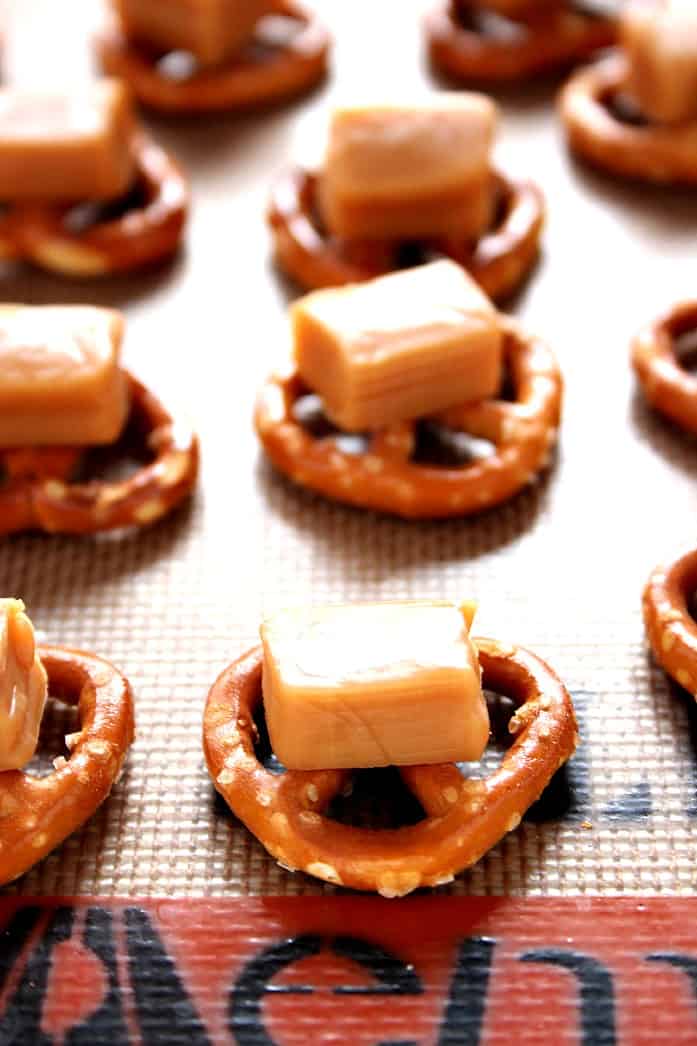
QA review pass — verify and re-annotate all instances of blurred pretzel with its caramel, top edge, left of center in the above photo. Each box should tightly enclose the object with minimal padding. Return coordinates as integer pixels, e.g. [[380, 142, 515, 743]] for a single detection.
[[97, 0, 331, 114]]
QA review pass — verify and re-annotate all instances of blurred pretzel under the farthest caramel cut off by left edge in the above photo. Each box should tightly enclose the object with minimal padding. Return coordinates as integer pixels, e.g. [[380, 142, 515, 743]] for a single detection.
[[0, 134, 188, 276]]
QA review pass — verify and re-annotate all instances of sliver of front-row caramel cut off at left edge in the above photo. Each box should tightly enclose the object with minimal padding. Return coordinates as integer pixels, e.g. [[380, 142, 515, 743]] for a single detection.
[[0, 599, 48, 771]]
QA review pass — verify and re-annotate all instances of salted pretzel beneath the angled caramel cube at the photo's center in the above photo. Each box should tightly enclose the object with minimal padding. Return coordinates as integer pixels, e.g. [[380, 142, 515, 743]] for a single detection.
[[254, 313, 562, 519]]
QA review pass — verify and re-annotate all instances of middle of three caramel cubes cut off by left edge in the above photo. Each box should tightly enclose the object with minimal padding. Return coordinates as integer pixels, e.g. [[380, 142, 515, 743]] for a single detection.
[[0, 305, 129, 447]]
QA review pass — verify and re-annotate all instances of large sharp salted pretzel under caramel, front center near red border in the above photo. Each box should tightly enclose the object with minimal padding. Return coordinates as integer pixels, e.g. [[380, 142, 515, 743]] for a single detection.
[[203, 639, 578, 896]]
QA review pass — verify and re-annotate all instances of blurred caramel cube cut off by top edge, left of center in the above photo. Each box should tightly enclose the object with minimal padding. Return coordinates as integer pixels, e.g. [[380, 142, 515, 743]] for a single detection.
[[114, 0, 273, 65]]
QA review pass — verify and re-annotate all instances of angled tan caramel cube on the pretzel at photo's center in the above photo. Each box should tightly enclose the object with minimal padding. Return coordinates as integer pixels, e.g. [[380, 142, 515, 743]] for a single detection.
[[291, 262, 503, 432]]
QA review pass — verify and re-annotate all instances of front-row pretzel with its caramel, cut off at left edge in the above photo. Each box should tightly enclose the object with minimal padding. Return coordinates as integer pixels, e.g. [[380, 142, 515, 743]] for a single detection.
[[0, 599, 134, 885]]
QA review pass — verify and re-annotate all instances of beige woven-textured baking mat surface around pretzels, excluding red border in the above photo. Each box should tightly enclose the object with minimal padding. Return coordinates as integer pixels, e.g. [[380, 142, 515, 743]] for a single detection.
[[0, 0, 697, 895]]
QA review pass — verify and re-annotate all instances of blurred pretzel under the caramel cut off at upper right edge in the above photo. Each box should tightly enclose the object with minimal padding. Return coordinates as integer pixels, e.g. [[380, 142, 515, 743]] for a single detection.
[[560, 54, 697, 185]]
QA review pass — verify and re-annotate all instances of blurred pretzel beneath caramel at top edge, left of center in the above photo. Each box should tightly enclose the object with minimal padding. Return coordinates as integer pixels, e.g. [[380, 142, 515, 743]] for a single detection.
[[97, 0, 331, 113]]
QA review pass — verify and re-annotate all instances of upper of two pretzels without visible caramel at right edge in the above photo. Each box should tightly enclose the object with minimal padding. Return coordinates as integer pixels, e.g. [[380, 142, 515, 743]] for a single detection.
[[631, 301, 697, 433]]
